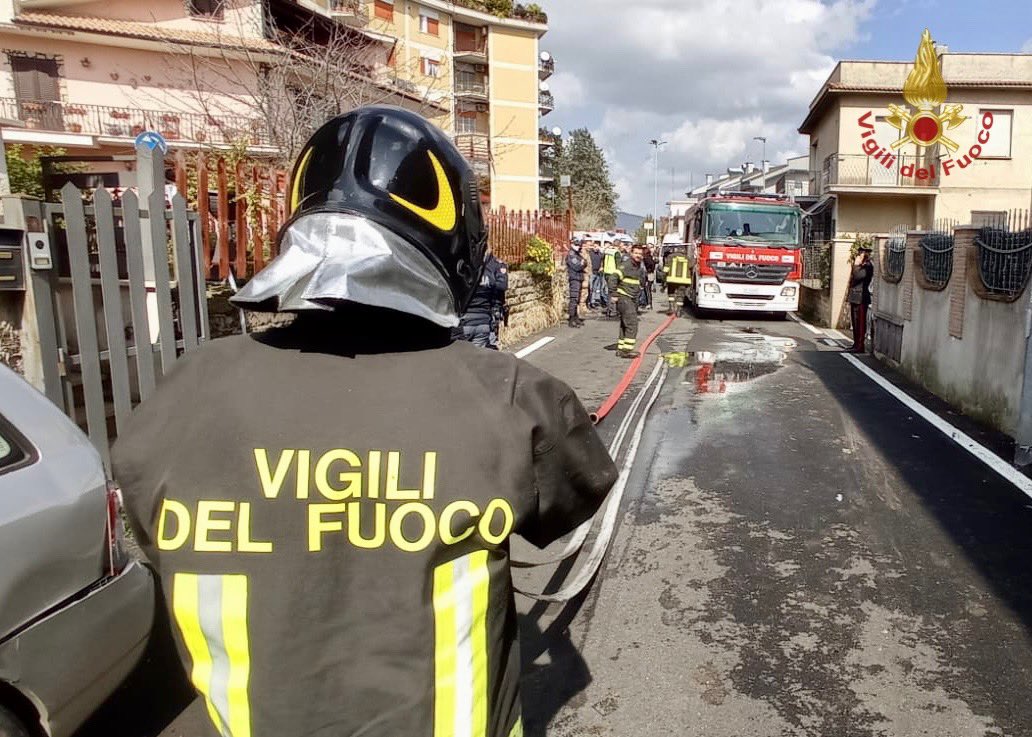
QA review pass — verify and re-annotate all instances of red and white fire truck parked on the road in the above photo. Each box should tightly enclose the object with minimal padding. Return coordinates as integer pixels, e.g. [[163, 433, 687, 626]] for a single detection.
[[684, 192, 803, 318]]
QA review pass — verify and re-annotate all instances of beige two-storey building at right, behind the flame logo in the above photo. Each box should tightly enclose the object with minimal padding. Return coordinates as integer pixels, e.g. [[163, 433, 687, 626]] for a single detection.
[[799, 45, 1032, 238]]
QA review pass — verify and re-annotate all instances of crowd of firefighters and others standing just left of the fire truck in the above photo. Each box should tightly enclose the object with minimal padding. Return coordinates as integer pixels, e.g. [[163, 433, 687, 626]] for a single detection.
[[566, 237, 691, 358]]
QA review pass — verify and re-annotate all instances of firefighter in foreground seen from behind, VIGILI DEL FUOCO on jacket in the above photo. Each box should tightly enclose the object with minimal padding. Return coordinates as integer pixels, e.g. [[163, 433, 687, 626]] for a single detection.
[[114, 107, 616, 737]]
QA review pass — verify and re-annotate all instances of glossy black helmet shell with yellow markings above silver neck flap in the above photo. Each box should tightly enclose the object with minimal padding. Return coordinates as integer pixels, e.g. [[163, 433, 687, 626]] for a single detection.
[[285, 105, 487, 314]]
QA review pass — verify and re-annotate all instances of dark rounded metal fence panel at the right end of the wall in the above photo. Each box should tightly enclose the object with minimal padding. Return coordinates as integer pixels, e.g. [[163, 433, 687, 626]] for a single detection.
[[974, 211, 1032, 298]]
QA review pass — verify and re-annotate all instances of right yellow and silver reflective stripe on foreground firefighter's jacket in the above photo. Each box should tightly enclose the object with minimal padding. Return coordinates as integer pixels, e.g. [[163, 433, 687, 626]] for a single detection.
[[433, 550, 490, 737]]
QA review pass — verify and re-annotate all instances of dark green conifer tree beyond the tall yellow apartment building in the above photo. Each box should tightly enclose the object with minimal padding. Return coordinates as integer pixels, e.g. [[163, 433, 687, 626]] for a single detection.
[[559, 128, 617, 230]]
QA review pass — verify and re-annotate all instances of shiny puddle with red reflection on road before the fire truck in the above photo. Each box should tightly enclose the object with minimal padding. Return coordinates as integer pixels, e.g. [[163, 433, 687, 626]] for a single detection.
[[664, 332, 798, 394]]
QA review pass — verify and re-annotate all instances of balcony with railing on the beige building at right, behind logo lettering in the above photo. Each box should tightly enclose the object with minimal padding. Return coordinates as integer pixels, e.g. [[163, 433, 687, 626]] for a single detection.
[[810, 154, 939, 195]]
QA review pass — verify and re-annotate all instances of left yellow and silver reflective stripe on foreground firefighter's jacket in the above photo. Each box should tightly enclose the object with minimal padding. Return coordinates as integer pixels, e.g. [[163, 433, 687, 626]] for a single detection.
[[172, 573, 251, 737]]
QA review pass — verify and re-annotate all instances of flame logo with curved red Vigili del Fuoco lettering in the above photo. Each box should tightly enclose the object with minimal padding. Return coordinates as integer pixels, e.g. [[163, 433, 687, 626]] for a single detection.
[[858, 29, 993, 182]]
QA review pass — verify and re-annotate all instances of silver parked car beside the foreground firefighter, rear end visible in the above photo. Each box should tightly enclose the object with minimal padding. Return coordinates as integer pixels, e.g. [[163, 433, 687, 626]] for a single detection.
[[0, 364, 155, 737]]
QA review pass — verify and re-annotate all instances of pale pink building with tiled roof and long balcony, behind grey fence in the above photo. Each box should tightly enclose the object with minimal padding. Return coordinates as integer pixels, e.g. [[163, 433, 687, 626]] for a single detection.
[[0, 0, 439, 187]]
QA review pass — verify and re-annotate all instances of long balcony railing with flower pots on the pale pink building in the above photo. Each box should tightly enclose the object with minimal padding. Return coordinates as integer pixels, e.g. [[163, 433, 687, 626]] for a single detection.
[[0, 97, 270, 146]]
